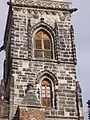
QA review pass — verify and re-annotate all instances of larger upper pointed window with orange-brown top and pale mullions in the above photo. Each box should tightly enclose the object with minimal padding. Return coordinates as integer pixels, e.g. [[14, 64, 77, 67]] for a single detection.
[[34, 30, 52, 59]]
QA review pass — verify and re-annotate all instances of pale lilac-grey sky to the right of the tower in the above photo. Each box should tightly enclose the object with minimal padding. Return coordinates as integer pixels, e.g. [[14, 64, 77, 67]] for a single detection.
[[72, 0, 90, 120]]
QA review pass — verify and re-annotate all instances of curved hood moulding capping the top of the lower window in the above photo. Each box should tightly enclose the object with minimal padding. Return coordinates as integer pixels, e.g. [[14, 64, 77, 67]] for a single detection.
[[36, 70, 58, 86]]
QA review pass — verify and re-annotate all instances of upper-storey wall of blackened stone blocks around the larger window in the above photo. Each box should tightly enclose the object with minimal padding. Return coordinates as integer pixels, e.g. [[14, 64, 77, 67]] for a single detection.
[[11, 8, 73, 63]]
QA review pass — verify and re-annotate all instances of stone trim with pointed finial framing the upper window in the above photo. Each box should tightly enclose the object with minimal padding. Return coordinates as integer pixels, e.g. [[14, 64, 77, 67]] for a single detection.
[[28, 18, 55, 59]]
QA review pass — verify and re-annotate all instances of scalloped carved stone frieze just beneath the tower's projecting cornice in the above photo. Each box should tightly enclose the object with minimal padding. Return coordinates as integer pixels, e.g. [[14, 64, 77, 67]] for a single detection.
[[11, 7, 71, 21]]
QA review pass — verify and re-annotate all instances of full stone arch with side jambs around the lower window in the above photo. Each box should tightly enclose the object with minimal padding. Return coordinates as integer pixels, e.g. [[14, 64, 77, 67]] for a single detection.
[[36, 70, 58, 108]]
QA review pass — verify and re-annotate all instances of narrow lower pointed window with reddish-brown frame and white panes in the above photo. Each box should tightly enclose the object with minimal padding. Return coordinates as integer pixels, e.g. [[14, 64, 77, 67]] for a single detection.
[[41, 79, 53, 108]]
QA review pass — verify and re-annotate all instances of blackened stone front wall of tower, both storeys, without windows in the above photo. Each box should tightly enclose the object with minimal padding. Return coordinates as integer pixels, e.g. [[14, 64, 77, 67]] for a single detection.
[[4, 0, 83, 120]]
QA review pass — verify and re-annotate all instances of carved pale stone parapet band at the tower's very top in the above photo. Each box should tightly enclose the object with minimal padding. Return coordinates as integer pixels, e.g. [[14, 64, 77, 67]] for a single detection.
[[12, 0, 71, 9]]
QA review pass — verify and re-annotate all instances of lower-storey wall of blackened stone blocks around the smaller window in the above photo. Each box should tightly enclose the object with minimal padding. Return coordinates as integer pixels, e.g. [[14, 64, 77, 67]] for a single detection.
[[12, 59, 77, 117]]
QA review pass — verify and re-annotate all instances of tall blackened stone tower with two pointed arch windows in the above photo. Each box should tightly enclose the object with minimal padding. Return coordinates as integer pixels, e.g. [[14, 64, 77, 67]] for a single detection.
[[4, 0, 84, 120]]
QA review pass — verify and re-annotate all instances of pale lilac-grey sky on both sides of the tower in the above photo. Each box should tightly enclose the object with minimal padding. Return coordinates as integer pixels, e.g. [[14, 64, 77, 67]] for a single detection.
[[0, 0, 90, 120]]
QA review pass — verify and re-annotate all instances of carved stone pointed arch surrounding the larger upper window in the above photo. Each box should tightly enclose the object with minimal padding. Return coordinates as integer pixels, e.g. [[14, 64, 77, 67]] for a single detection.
[[29, 20, 55, 59]]
